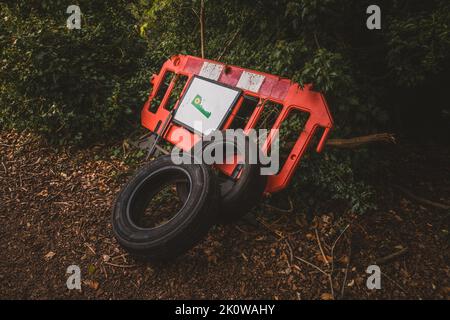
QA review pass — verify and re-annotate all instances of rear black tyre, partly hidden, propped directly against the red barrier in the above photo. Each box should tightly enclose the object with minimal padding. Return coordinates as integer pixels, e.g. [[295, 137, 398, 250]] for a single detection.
[[177, 134, 267, 224]]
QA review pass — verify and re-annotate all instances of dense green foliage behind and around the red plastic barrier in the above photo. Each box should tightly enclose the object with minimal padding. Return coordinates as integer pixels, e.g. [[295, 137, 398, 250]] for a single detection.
[[0, 0, 450, 211]]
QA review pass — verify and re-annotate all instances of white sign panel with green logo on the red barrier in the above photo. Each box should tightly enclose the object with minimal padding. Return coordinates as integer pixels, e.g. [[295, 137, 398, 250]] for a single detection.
[[174, 77, 241, 135]]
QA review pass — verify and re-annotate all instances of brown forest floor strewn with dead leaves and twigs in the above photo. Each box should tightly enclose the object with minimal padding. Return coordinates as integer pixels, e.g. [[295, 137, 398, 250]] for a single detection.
[[0, 132, 450, 299]]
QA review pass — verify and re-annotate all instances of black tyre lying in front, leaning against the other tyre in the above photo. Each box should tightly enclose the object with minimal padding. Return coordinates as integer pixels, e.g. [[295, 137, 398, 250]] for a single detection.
[[112, 156, 217, 261]]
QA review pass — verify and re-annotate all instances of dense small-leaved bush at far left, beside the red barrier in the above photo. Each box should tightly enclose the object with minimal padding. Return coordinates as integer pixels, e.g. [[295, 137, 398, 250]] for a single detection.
[[0, 1, 152, 143]]
